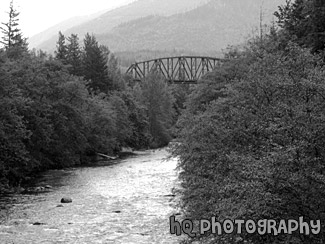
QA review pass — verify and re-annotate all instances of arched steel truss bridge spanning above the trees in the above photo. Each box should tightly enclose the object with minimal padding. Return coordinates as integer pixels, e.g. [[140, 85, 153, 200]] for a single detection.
[[126, 56, 222, 83]]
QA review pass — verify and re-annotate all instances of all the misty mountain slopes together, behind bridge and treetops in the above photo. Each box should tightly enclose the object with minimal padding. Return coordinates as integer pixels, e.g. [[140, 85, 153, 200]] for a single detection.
[[31, 0, 285, 54]]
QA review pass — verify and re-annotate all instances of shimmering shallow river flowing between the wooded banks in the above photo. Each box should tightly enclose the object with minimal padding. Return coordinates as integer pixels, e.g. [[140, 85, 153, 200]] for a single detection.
[[0, 149, 181, 244]]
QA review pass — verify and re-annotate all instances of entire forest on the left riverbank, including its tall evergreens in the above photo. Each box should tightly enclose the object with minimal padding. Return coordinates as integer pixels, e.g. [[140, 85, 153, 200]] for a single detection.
[[0, 4, 182, 191]]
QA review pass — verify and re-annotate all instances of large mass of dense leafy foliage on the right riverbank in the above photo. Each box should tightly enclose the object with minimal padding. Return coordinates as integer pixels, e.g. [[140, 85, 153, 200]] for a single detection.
[[173, 1, 325, 243]]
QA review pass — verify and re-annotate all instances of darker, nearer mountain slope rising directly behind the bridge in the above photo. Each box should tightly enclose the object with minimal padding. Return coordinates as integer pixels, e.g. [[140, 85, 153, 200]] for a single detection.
[[97, 0, 284, 54]]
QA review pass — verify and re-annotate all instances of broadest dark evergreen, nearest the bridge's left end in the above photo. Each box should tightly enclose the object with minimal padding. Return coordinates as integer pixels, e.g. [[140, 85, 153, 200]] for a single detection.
[[83, 33, 112, 93]]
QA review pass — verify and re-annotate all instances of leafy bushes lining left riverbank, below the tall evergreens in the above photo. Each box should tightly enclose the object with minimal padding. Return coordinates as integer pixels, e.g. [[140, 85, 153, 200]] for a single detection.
[[0, 52, 177, 189]]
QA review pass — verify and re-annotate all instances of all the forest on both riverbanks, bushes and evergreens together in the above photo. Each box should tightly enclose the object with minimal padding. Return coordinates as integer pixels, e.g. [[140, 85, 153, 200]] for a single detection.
[[0, 0, 325, 243]]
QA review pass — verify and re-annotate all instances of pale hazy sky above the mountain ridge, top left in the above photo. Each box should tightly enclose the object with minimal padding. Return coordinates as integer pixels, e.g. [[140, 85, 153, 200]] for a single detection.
[[0, 0, 134, 37]]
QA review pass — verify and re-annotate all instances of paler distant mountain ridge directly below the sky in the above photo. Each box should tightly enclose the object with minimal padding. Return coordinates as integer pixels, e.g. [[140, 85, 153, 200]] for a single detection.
[[33, 0, 209, 52]]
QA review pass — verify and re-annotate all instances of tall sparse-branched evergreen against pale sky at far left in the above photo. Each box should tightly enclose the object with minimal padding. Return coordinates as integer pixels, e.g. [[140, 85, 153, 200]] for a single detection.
[[0, 0, 28, 58]]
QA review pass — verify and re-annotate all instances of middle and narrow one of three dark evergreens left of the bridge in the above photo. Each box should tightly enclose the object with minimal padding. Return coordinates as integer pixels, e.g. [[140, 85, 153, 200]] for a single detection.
[[66, 34, 83, 76]]
